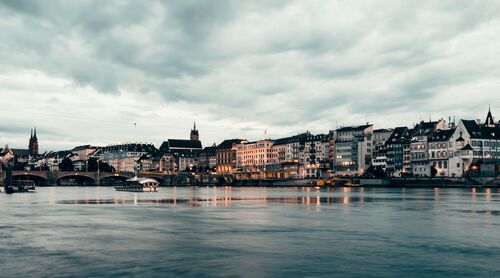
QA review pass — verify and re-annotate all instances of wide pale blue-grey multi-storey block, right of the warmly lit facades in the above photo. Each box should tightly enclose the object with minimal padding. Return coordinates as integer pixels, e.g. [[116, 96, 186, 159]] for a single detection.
[[335, 124, 373, 175]]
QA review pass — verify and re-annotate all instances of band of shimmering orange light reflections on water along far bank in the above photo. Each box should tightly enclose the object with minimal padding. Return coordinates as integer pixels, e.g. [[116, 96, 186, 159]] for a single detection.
[[32, 187, 500, 207]]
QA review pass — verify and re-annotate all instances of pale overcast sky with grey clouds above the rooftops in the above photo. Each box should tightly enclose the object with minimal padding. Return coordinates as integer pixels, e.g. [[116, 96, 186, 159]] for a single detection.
[[0, 0, 500, 151]]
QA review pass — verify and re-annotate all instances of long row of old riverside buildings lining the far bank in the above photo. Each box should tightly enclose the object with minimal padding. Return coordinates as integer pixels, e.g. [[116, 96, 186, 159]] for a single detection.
[[3, 110, 500, 179]]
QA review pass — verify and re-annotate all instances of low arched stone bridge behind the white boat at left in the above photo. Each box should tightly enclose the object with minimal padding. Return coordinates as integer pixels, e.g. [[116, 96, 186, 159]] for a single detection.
[[0, 171, 177, 186]]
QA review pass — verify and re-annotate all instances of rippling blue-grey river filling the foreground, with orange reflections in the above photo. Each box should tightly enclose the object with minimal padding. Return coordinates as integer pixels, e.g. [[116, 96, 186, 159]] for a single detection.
[[0, 187, 500, 277]]
